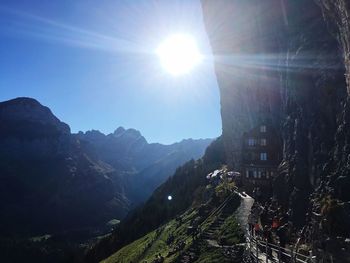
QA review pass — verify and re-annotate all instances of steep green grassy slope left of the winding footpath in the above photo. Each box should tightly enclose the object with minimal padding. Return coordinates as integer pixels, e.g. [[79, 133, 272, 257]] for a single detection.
[[102, 194, 244, 263]]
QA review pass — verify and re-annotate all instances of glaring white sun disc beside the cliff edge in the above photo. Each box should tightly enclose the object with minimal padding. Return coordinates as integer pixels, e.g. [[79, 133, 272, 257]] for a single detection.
[[157, 34, 202, 75]]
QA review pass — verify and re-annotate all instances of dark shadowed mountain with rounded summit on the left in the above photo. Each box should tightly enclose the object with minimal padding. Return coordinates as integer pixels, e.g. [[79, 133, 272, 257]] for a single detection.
[[0, 98, 128, 235]]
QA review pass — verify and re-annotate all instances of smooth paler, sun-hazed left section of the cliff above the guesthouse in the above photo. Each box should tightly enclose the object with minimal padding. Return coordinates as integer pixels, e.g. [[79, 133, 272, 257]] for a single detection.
[[202, 0, 285, 169]]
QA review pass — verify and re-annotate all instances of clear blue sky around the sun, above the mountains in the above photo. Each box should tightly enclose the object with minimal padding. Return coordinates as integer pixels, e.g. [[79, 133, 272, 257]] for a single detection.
[[0, 0, 221, 143]]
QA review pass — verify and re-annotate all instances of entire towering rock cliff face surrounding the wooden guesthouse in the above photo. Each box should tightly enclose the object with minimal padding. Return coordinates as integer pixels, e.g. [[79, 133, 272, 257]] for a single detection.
[[202, 0, 350, 250]]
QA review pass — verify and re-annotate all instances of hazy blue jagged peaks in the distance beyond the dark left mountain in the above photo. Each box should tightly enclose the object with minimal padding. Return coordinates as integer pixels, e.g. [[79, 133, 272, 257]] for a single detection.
[[76, 130, 212, 204]]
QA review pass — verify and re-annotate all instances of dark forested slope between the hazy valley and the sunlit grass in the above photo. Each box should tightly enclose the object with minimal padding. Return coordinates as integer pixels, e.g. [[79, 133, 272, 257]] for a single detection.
[[85, 137, 226, 262]]
